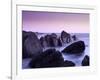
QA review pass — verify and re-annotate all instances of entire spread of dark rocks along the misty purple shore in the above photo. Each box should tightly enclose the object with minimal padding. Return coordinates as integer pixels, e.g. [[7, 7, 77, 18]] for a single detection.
[[22, 31, 89, 68]]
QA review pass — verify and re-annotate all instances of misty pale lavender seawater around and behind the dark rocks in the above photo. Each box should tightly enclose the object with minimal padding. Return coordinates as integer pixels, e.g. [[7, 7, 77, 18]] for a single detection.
[[22, 33, 90, 69]]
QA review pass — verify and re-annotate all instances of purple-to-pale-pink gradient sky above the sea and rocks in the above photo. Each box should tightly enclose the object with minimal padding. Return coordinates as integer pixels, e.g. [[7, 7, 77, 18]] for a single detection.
[[22, 11, 89, 33]]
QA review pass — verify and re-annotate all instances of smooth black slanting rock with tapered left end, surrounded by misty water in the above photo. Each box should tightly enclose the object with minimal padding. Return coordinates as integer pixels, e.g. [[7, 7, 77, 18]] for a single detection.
[[62, 41, 85, 54]]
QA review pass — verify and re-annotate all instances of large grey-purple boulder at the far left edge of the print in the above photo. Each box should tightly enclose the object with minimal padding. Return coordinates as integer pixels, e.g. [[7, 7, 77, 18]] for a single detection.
[[22, 32, 43, 58]]
